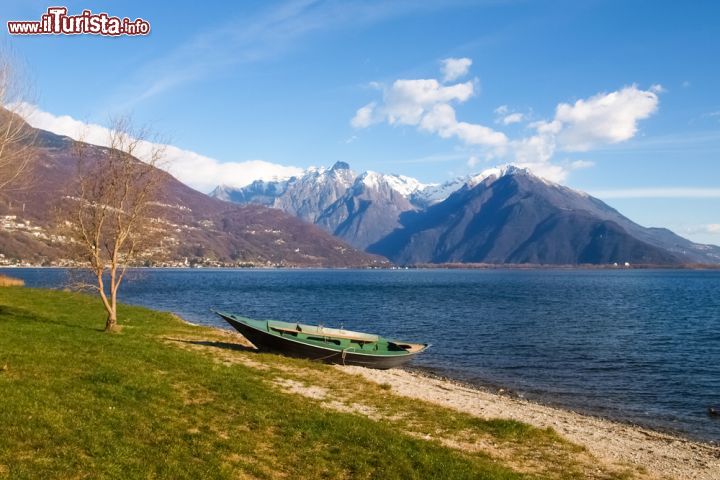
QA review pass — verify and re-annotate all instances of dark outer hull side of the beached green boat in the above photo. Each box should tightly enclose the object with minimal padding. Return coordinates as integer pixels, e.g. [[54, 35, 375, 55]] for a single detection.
[[218, 313, 428, 370]]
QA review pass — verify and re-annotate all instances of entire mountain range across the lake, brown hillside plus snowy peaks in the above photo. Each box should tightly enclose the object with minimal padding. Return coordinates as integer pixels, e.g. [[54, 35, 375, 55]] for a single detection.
[[0, 110, 720, 267]]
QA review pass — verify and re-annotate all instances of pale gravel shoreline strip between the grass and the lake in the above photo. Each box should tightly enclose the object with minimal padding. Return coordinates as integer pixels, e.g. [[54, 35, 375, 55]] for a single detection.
[[186, 316, 720, 480]]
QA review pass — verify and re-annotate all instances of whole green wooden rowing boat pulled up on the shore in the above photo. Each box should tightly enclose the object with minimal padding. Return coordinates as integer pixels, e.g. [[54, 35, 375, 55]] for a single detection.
[[215, 312, 430, 369]]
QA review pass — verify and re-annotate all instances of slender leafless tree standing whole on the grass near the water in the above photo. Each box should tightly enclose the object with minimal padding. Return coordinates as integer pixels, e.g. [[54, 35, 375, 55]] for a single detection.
[[66, 117, 167, 331]]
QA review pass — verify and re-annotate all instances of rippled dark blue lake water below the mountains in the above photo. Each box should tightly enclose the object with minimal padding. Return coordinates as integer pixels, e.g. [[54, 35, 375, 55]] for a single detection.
[[5, 269, 720, 442]]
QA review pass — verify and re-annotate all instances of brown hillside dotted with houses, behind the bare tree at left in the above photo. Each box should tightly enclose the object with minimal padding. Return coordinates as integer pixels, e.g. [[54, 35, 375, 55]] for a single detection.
[[0, 119, 388, 267]]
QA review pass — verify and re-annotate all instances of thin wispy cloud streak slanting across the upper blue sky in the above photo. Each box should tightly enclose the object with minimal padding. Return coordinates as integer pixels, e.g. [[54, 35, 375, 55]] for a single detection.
[[119, 0, 478, 107]]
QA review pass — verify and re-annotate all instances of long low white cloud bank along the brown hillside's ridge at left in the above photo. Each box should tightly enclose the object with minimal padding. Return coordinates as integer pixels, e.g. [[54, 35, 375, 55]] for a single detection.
[[16, 104, 303, 192]]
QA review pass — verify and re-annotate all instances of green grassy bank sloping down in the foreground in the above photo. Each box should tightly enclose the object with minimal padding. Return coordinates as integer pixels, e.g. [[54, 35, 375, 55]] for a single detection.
[[0, 287, 627, 479]]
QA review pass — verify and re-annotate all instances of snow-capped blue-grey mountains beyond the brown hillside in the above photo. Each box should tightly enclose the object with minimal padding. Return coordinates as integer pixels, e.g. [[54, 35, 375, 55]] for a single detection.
[[210, 162, 720, 265]]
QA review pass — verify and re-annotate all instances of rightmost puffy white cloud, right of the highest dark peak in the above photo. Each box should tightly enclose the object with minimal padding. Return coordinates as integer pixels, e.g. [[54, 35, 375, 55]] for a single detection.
[[555, 85, 660, 151]]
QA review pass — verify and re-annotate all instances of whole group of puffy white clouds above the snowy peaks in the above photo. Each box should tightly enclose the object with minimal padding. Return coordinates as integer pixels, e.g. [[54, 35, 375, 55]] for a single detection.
[[351, 59, 664, 182]]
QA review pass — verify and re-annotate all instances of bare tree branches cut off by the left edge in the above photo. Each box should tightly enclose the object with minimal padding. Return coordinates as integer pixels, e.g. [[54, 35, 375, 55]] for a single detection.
[[0, 52, 35, 191]]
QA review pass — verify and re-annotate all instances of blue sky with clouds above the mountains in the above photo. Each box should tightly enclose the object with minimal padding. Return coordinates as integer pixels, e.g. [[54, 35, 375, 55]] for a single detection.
[[2, 0, 720, 244]]
